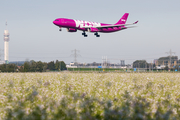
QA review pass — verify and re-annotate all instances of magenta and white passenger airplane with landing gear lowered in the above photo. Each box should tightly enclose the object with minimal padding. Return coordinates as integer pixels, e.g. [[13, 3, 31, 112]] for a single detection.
[[53, 13, 138, 37]]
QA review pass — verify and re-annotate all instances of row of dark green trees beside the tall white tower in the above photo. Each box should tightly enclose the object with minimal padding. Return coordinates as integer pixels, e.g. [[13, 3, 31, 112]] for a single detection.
[[0, 60, 67, 72]]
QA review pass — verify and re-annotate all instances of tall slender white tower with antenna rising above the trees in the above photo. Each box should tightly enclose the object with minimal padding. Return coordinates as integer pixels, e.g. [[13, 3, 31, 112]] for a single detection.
[[4, 22, 9, 64]]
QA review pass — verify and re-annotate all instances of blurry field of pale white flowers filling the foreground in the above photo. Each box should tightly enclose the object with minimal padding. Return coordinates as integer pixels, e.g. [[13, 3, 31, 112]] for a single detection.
[[0, 72, 180, 120]]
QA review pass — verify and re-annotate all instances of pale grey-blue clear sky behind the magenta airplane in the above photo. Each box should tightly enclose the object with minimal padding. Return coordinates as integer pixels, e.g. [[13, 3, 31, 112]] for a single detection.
[[0, 0, 180, 63]]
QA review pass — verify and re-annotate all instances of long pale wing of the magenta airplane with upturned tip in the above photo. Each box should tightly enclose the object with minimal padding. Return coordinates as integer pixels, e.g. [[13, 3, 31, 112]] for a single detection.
[[82, 21, 138, 29]]
